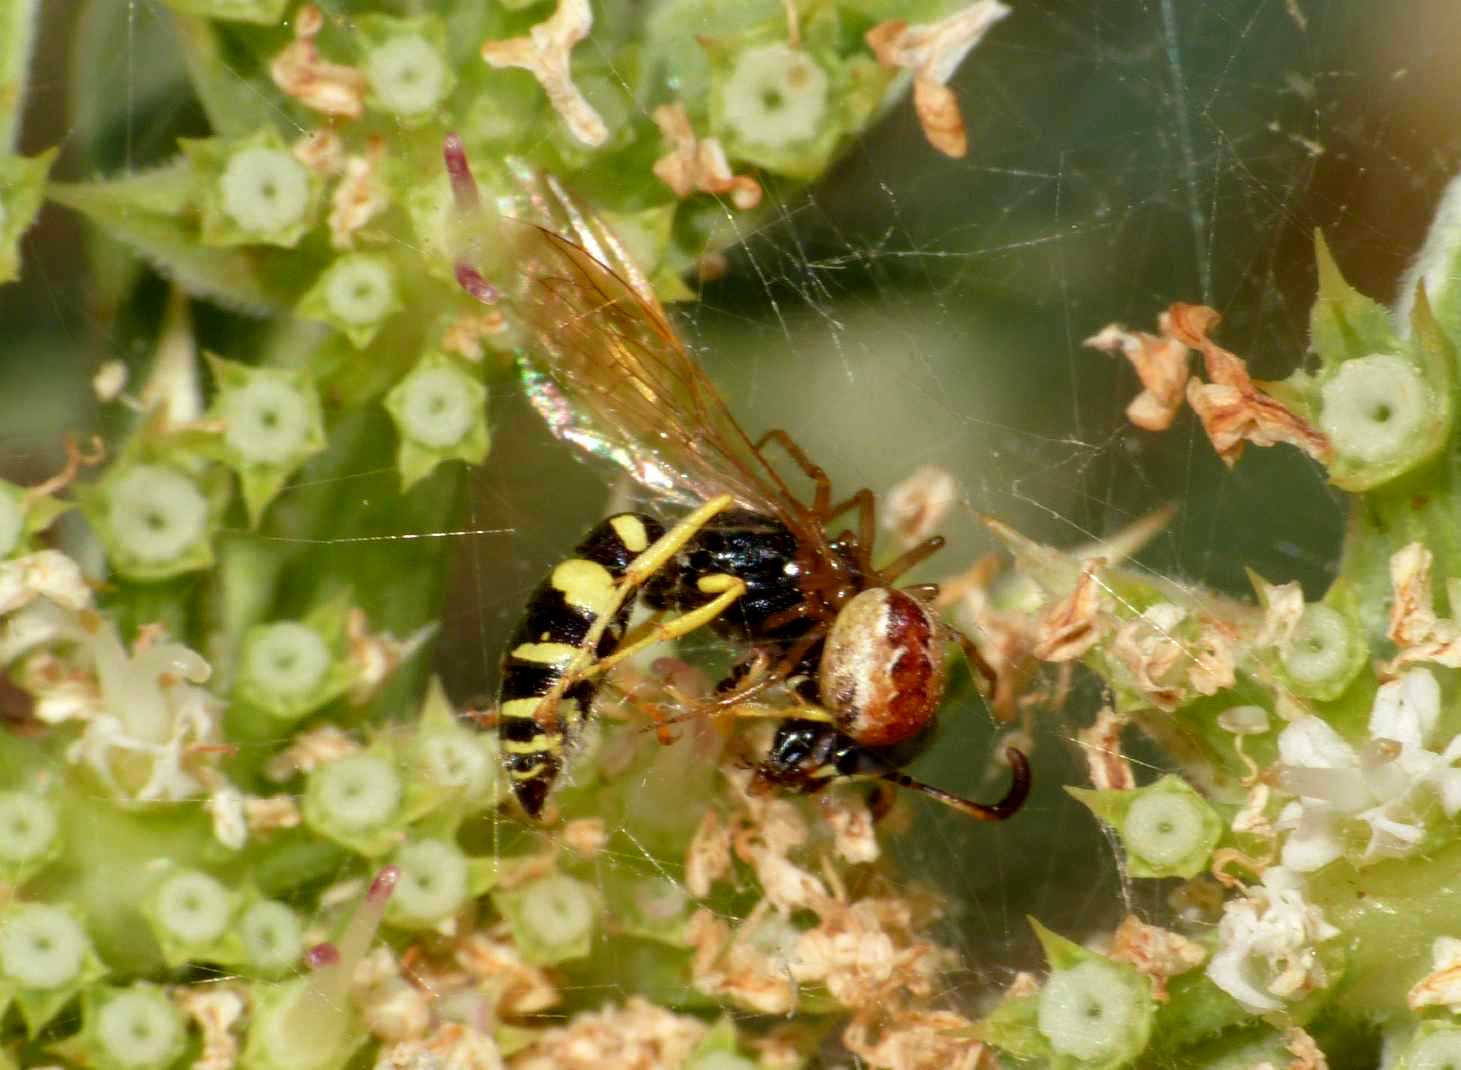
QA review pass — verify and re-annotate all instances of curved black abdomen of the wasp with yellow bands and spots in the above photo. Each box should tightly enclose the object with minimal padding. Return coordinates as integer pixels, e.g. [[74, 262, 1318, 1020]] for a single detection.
[[497, 513, 665, 817]]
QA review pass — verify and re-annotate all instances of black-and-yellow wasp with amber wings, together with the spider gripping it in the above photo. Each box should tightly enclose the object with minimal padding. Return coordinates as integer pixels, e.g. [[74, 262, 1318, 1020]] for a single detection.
[[444, 134, 1030, 820]]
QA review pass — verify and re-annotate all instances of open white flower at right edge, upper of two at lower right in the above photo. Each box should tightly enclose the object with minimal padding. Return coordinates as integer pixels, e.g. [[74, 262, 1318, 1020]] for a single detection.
[[1278, 668, 1461, 873]]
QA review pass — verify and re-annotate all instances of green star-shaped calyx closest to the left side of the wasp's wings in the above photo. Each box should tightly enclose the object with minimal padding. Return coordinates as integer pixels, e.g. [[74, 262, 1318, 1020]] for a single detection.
[[386, 352, 491, 487]]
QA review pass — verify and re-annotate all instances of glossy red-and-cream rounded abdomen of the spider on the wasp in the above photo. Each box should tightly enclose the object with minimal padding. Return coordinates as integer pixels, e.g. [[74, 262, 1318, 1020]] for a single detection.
[[821, 588, 944, 747]]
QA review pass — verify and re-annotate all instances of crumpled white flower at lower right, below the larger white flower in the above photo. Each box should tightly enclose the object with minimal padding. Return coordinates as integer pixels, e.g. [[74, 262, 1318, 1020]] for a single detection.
[[1207, 865, 1340, 1014]]
